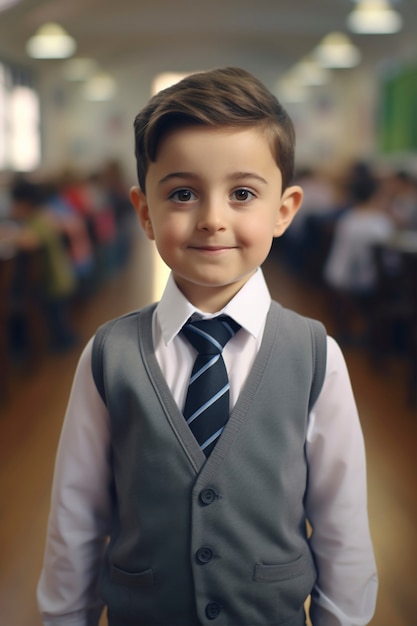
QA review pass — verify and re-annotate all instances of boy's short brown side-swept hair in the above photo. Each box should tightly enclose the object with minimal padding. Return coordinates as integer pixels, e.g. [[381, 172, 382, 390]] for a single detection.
[[134, 67, 295, 192]]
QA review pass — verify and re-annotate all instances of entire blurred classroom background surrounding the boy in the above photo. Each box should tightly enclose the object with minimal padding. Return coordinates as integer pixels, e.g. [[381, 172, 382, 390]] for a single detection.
[[0, 0, 417, 626]]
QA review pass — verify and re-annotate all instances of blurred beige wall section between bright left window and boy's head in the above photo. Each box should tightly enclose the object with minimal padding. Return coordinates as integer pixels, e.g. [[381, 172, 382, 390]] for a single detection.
[[39, 57, 156, 184]]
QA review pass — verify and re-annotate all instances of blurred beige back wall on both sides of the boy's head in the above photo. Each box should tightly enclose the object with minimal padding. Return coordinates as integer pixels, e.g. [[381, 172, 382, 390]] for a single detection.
[[33, 60, 416, 184]]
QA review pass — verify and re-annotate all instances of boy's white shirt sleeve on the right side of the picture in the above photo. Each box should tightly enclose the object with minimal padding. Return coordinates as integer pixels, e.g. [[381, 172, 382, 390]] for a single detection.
[[306, 338, 378, 626]]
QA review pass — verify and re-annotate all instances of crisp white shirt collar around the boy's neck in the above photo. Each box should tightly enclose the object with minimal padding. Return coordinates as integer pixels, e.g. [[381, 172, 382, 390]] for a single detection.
[[156, 268, 271, 345]]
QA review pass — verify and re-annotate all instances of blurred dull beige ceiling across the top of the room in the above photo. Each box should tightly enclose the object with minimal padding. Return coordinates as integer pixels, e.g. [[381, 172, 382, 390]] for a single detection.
[[0, 0, 417, 88]]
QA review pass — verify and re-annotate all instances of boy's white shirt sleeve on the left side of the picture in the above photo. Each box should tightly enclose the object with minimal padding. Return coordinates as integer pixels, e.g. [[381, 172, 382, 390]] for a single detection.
[[37, 340, 111, 626]]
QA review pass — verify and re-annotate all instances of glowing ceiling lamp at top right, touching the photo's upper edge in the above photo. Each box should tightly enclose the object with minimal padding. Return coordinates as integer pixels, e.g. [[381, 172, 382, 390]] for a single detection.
[[347, 0, 403, 35]]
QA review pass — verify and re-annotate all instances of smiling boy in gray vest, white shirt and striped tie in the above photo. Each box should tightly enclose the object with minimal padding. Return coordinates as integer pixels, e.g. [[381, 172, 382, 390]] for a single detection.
[[38, 68, 377, 626]]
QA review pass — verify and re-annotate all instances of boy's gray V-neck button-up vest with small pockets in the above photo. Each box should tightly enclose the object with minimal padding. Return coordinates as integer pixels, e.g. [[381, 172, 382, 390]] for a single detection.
[[93, 303, 326, 626]]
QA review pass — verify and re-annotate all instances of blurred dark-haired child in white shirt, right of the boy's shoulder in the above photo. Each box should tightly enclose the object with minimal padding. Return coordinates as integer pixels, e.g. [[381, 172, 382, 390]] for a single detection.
[[324, 164, 395, 342]]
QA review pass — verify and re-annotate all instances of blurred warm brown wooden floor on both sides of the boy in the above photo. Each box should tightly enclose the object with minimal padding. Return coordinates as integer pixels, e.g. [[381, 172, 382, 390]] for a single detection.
[[0, 229, 417, 626]]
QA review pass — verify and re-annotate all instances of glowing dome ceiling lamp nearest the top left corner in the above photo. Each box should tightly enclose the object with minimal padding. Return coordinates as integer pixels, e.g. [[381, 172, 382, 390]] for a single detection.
[[26, 22, 76, 59]]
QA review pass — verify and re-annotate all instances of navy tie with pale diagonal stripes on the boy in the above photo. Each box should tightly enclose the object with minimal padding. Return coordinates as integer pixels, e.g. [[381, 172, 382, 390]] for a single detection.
[[181, 315, 240, 456]]
